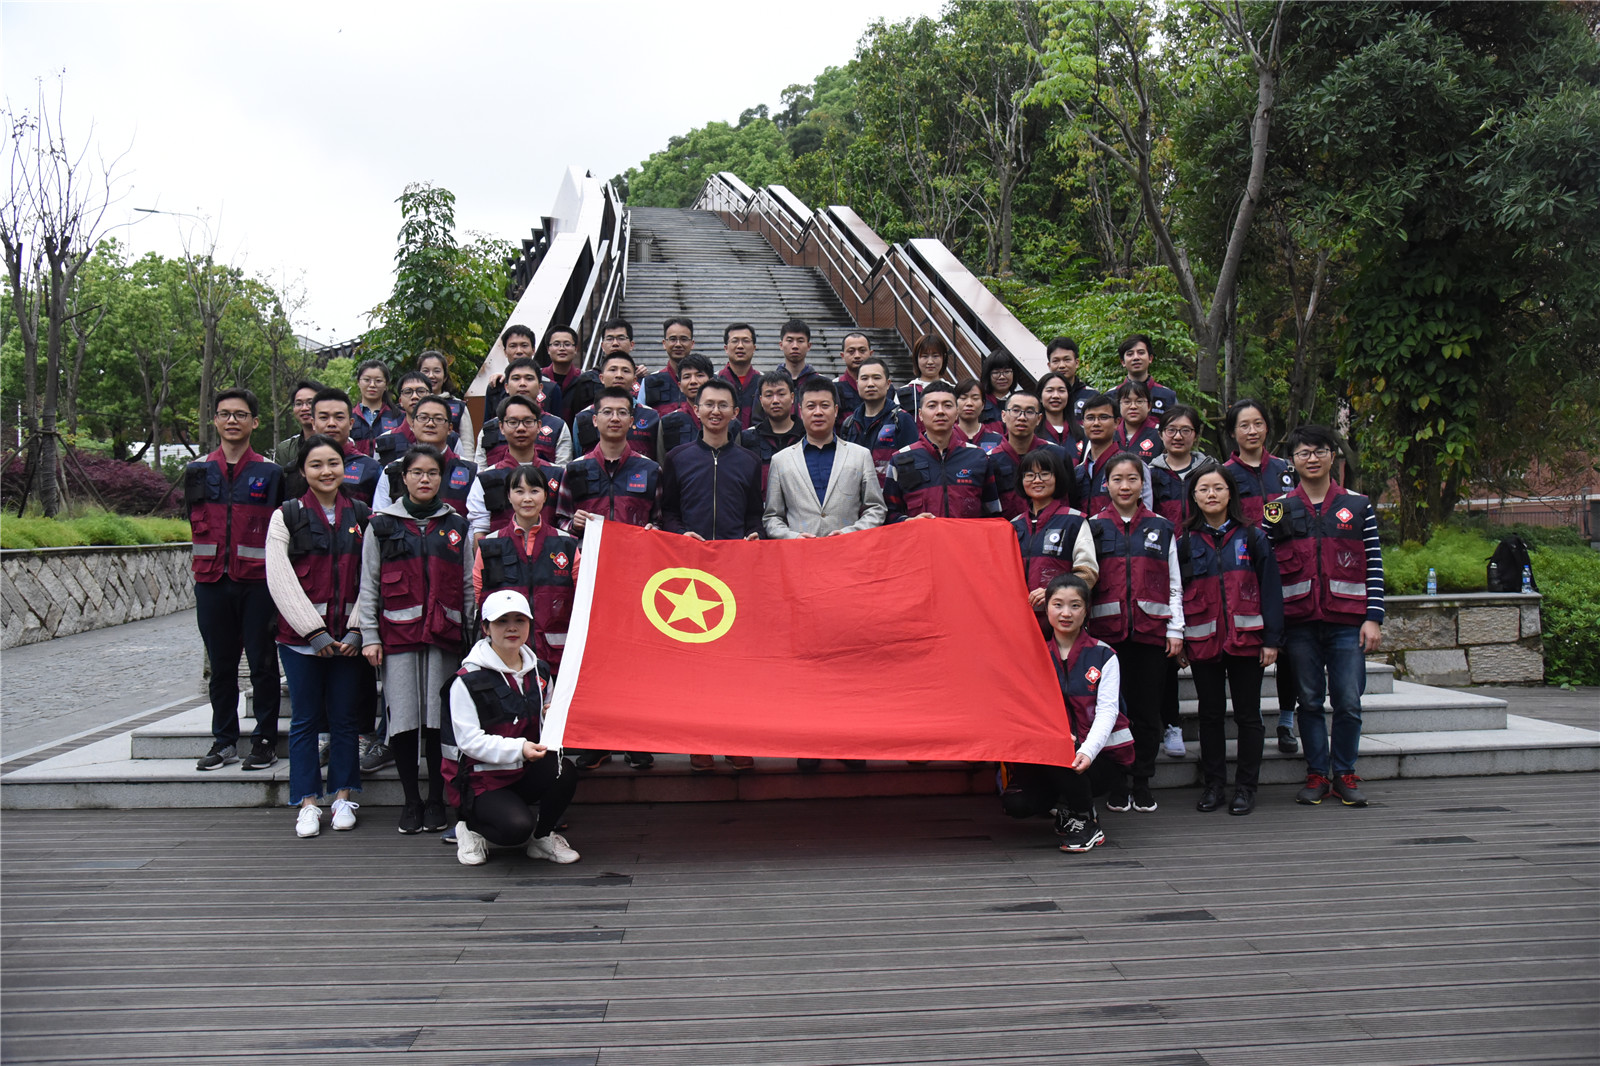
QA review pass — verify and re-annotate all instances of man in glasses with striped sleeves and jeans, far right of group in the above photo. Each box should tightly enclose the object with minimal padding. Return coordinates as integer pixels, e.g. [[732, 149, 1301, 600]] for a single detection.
[[1262, 426, 1384, 807]]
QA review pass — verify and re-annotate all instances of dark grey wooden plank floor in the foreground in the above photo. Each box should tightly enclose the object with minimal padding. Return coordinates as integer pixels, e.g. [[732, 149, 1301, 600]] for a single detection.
[[0, 775, 1600, 1066]]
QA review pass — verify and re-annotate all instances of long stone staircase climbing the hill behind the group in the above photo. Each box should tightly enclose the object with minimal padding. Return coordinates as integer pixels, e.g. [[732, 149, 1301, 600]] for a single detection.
[[618, 208, 914, 381]]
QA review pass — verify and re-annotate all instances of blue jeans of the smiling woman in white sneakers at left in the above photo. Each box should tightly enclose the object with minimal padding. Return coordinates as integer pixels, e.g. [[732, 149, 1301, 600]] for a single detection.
[[278, 647, 362, 807]]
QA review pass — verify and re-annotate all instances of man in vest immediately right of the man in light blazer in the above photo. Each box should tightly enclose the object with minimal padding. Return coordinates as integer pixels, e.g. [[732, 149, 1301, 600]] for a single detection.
[[883, 381, 1000, 523]]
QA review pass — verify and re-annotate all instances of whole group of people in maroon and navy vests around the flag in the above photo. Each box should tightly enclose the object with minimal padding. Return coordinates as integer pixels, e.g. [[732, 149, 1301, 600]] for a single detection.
[[186, 317, 1384, 864]]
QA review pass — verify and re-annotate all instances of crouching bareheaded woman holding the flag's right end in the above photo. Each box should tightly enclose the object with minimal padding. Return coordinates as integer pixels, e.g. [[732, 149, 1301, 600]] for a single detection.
[[1000, 573, 1133, 852]]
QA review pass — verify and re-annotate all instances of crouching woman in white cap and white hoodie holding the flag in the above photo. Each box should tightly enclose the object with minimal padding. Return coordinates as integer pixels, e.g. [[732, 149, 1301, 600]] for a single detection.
[[443, 589, 578, 866]]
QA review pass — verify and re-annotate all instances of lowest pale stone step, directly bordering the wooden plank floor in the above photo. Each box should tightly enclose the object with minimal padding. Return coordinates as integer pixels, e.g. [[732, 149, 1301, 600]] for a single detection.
[[0, 715, 1600, 809]]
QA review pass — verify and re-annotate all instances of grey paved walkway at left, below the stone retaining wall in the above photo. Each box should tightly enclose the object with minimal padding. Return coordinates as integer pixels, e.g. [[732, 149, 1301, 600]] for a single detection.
[[0, 610, 202, 759]]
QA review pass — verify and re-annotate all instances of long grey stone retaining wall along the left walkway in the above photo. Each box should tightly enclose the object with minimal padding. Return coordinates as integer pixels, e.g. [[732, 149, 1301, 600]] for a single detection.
[[0, 544, 195, 648]]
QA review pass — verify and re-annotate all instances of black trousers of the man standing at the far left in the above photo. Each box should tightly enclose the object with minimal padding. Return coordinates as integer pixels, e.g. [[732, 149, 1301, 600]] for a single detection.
[[195, 578, 278, 746]]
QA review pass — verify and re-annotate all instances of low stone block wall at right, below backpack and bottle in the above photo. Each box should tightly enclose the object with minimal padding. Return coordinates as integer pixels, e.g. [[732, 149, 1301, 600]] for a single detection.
[[1382, 592, 1544, 685]]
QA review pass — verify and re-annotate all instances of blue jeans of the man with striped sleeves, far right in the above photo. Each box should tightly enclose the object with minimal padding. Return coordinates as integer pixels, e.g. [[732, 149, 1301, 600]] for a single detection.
[[1283, 621, 1366, 778]]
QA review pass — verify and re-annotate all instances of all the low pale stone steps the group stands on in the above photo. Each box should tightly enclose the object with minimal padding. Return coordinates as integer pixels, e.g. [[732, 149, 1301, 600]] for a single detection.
[[0, 663, 1600, 810]]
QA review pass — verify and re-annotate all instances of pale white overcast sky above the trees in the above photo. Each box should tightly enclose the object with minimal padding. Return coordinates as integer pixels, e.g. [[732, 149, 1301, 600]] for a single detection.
[[0, 0, 939, 341]]
